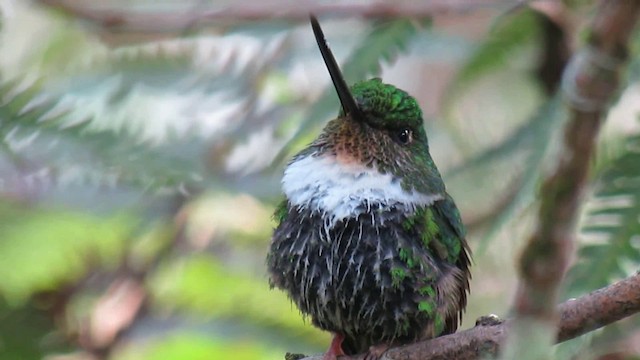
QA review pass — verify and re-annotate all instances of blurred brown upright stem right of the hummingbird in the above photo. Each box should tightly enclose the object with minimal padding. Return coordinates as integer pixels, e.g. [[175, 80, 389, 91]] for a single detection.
[[514, 0, 640, 326]]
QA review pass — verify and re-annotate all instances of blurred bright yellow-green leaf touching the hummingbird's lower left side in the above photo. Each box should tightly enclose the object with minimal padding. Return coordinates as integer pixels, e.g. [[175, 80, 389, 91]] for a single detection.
[[149, 255, 328, 345]]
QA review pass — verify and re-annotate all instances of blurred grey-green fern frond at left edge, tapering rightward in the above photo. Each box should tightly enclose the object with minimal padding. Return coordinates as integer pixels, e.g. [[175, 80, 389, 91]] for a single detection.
[[0, 74, 202, 188]]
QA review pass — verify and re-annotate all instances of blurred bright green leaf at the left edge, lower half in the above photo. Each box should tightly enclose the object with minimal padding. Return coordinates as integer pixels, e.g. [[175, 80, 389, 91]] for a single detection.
[[0, 202, 134, 306]]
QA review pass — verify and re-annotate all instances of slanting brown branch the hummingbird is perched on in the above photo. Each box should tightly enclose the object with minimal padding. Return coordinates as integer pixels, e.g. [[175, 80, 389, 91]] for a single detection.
[[298, 274, 640, 360]]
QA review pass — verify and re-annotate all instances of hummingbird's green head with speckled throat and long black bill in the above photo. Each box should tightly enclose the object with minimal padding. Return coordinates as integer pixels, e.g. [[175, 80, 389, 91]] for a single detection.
[[308, 17, 444, 194]]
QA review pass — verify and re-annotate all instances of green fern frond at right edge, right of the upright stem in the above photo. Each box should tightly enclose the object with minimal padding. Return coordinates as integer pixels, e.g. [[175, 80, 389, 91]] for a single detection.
[[566, 134, 640, 297]]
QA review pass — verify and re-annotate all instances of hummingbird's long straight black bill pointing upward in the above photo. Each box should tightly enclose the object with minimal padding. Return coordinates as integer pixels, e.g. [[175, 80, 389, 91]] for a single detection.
[[310, 15, 362, 119]]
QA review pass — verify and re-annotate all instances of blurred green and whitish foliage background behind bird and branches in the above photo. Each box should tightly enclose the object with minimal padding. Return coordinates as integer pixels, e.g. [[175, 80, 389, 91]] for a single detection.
[[0, 0, 640, 360]]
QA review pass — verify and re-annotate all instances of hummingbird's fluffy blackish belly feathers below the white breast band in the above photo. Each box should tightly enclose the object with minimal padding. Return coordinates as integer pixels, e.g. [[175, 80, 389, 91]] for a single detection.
[[268, 207, 459, 353]]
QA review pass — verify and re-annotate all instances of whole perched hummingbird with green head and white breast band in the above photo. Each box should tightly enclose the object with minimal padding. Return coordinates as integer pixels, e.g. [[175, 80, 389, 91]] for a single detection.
[[267, 16, 471, 360]]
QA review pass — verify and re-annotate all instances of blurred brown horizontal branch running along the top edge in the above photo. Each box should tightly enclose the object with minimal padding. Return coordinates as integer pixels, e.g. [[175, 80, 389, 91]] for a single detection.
[[39, 0, 514, 33]]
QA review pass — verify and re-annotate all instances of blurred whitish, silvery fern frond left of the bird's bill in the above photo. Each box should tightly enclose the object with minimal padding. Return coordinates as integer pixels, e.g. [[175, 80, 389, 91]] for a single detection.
[[45, 35, 284, 143]]
